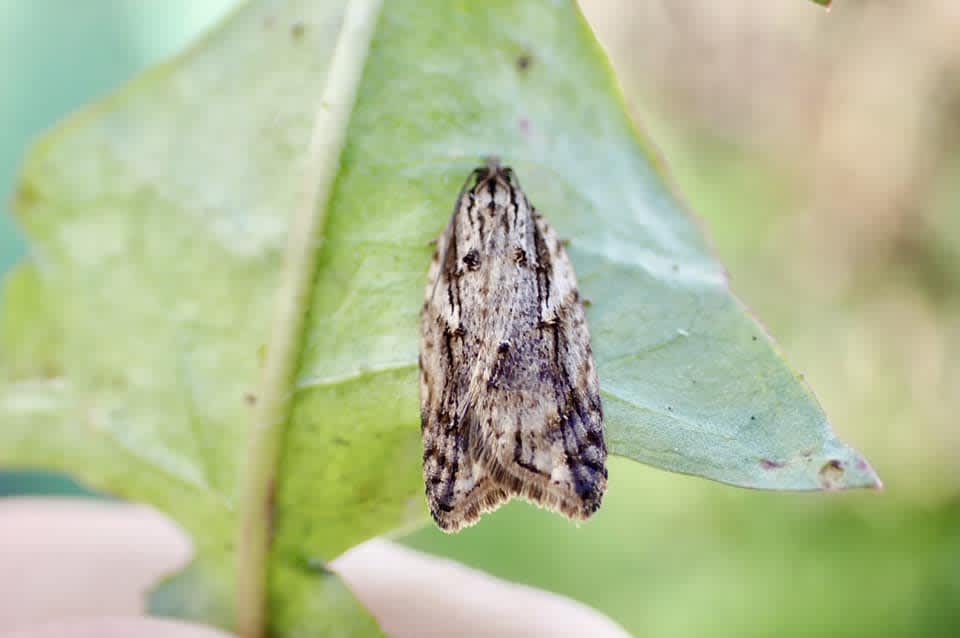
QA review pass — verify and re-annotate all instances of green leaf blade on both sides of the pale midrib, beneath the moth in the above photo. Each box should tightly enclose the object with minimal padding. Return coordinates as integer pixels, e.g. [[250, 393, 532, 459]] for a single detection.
[[0, 0, 878, 636]]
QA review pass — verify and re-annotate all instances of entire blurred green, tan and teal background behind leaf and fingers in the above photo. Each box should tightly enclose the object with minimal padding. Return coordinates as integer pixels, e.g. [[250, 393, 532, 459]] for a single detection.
[[0, 0, 960, 637]]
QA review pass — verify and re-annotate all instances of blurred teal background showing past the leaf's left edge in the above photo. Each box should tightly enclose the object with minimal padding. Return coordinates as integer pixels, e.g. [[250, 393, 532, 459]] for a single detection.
[[0, 0, 235, 495]]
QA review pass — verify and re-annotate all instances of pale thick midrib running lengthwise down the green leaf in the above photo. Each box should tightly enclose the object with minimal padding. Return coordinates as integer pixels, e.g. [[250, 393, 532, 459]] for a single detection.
[[236, 0, 382, 638]]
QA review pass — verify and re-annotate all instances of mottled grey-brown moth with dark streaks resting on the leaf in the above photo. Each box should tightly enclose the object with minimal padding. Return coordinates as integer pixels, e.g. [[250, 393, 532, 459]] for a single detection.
[[420, 160, 607, 532]]
